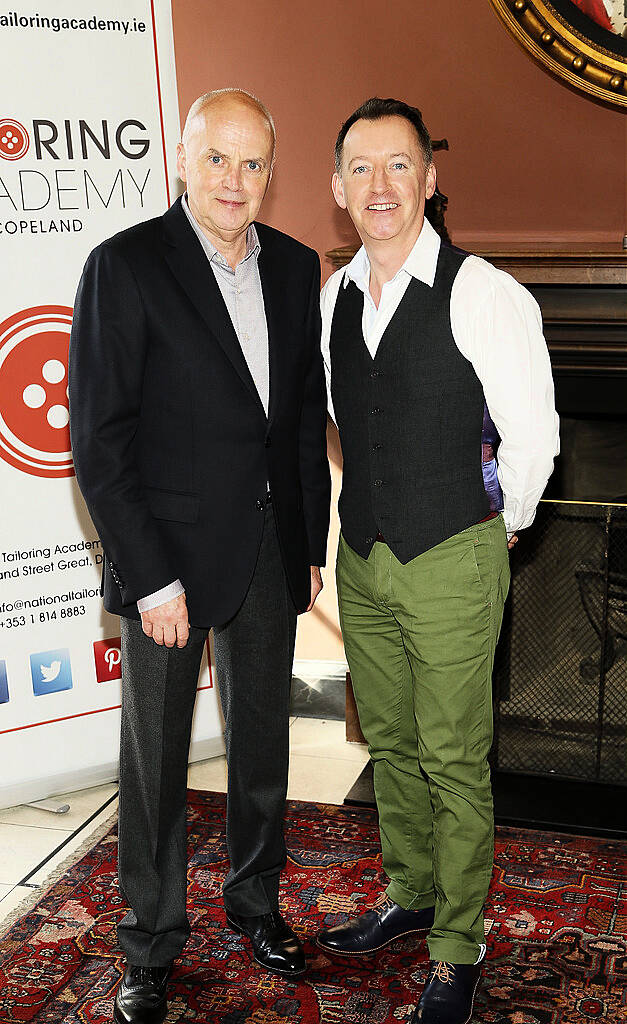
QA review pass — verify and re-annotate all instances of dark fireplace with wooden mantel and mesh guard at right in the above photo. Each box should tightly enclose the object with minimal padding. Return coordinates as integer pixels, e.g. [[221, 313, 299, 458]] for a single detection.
[[489, 252, 627, 815]]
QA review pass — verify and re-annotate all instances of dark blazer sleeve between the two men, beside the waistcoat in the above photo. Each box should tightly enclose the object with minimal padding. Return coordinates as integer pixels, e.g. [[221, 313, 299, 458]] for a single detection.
[[299, 250, 331, 565]]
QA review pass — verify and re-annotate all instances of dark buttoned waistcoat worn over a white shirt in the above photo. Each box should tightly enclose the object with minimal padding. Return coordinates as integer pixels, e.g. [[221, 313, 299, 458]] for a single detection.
[[331, 243, 490, 564]]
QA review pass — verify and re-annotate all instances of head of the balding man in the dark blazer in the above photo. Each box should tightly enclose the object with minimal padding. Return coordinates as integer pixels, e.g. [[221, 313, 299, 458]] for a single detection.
[[176, 93, 273, 250]]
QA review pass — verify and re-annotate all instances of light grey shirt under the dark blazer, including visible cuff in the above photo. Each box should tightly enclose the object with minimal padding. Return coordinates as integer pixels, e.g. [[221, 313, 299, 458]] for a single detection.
[[137, 195, 269, 611]]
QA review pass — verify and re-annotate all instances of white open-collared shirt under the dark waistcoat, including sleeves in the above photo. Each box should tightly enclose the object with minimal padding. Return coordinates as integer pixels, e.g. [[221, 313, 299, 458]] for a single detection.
[[321, 218, 559, 536]]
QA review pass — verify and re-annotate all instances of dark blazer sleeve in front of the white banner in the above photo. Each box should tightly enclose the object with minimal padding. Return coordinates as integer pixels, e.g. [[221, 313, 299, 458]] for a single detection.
[[69, 243, 177, 604]]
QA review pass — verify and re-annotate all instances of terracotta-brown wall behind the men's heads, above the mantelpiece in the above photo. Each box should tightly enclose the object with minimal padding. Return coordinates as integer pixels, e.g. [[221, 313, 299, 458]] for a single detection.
[[173, 0, 627, 278]]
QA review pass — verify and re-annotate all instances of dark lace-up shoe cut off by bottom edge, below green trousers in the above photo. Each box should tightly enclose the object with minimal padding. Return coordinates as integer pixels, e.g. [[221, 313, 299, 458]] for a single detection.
[[409, 961, 482, 1024]]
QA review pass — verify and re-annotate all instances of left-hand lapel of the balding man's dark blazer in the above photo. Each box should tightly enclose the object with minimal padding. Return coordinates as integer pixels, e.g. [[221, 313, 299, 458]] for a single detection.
[[163, 199, 264, 415]]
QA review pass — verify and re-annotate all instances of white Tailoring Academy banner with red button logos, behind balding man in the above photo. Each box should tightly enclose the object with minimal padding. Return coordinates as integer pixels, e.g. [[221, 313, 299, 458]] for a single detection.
[[0, 0, 222, 807]]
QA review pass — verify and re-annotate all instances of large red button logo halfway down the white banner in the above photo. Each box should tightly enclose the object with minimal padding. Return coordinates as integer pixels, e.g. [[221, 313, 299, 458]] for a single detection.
[[0, 306, 74, 477]]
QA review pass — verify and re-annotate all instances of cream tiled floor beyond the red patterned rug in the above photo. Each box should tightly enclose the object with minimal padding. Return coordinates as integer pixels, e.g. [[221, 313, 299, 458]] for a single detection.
[[0, 718, 368, 929]]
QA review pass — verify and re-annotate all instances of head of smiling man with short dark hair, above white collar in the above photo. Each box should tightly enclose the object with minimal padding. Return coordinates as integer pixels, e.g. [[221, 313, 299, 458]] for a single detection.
[[331, 116, 435, 253]]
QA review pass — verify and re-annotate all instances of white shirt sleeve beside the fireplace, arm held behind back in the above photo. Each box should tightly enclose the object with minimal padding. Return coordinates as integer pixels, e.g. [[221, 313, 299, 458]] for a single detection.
[[451, 256, 559, 536]]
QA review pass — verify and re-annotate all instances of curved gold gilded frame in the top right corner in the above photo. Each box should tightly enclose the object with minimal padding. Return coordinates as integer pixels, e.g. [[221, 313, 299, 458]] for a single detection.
[[491, 0, 627, 106]]
